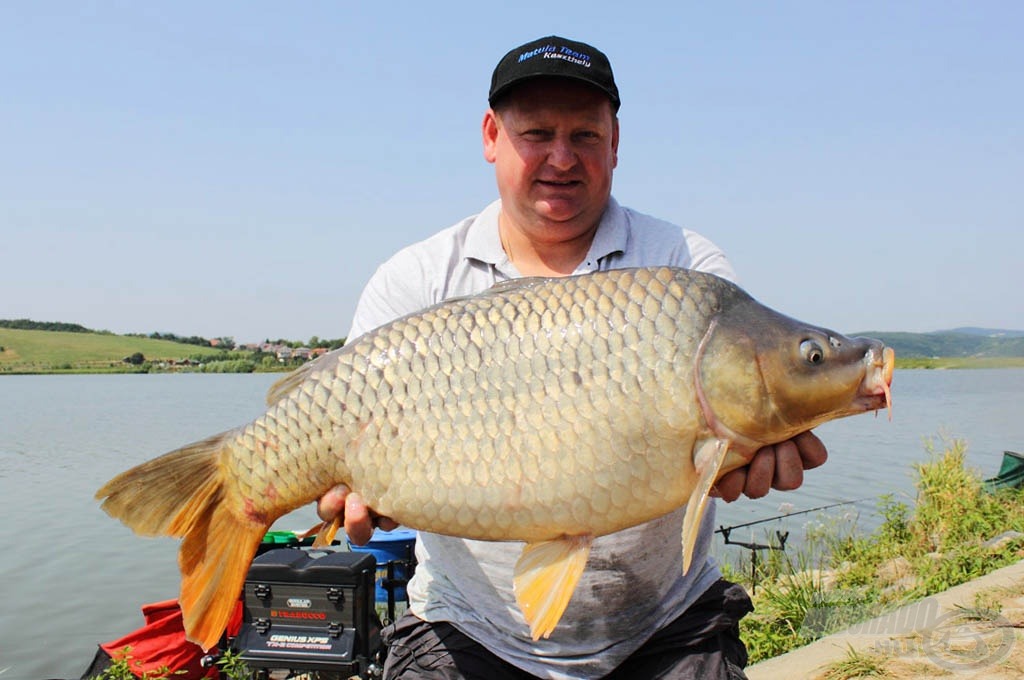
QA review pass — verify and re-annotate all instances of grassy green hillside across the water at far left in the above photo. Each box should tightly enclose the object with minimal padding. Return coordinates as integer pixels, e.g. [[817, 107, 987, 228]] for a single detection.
[[0, 328, 225, 374]]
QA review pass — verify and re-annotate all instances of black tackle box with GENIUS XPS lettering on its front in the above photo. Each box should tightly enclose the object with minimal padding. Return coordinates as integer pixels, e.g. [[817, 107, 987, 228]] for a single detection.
[[231, 548, 381, 677]]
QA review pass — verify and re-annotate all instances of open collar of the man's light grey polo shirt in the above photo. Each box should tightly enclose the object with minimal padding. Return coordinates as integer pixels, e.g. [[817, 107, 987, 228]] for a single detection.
[[465, 197, 629, 267]]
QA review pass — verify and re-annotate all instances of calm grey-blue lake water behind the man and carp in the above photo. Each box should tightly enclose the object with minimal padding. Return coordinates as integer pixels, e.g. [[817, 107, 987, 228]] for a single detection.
[[0, 370, 1024, 680]]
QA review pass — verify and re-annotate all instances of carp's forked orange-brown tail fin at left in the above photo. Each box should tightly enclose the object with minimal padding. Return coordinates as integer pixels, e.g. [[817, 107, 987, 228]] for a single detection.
[[96, 433, 273, 649]]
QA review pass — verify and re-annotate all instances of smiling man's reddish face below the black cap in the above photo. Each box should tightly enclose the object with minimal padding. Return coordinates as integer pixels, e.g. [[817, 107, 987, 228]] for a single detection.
[[483, 78, 618, 242]]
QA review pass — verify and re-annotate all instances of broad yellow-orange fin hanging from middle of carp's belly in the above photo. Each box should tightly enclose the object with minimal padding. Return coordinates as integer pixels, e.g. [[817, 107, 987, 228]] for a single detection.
[[512, 535, 594, 640]]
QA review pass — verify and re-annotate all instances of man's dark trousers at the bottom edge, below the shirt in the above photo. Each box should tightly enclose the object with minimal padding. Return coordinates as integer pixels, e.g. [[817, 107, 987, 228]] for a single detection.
[[384, 580, 754, 680]]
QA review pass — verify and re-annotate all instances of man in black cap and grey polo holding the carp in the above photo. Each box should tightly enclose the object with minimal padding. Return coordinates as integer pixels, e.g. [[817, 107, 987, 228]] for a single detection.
[[318, 36, 825, 680]]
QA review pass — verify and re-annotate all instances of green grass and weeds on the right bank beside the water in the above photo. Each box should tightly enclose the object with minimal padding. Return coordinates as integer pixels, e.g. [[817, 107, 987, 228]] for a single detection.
[[727, 441, 1024, 663]]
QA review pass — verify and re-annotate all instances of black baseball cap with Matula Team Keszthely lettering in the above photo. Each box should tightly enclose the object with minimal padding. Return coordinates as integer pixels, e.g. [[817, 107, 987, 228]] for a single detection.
[[487, 36, 621, 111]]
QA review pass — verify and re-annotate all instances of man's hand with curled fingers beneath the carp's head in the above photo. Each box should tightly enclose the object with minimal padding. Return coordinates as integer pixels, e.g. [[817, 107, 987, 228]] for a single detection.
[[712, 432, 828, 503]]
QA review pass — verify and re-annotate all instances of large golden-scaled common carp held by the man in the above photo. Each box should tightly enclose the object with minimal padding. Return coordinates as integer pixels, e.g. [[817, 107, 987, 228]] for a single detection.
[[96, 267, 894, 648]]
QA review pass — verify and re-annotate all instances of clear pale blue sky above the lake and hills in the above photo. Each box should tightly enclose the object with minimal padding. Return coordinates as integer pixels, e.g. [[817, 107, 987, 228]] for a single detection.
[[0, 0, 1024, 342]]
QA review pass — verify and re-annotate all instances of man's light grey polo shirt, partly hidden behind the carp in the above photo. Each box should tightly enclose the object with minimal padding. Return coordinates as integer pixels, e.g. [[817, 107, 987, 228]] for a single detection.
[[348, 199, 735, 678]]
